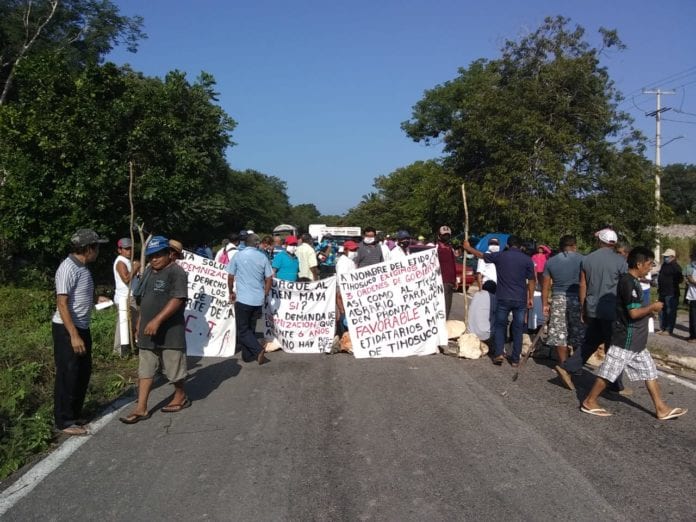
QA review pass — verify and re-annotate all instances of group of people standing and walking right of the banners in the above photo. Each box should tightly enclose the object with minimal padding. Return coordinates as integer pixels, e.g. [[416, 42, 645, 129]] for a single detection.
[[463, 228, 696, 420]]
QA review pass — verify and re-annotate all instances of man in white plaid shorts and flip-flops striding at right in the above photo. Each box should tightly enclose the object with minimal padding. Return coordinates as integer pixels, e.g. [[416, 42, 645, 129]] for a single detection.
[[580, 247, 687, 420]]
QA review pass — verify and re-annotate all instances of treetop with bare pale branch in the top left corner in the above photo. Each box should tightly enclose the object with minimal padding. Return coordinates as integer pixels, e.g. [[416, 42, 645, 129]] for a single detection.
[[0, 0, 146, 105]]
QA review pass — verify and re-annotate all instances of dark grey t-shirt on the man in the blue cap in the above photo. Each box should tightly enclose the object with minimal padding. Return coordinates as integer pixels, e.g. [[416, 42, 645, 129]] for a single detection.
[[138, 263, 188, 350]]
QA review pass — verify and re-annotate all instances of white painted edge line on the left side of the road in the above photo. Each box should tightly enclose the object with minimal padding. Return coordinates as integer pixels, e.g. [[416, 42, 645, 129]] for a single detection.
[[0, 398, 133, 517]]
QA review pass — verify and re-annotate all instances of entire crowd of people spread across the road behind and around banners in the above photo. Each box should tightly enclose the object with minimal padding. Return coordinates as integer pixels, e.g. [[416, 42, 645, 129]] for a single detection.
[[52, 225, 696, 435]]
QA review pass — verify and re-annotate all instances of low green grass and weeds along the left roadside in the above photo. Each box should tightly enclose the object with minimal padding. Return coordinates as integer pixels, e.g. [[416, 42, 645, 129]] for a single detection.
[[0, 287, 137, 479]]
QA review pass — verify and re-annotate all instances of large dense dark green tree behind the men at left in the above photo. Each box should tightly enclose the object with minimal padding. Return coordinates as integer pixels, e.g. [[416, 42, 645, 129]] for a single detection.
[[0, 53, 235, 274]]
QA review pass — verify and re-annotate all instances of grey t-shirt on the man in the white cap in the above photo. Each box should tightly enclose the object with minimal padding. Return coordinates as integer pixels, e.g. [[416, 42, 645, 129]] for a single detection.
[[582, 247, 628, 321]]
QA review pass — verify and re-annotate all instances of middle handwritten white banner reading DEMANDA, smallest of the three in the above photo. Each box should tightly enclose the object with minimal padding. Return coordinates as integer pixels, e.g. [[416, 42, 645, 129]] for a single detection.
[[263, 277, 336, 353]]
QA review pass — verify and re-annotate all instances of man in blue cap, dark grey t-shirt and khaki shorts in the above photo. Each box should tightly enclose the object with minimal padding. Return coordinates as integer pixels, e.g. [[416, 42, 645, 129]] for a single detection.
[[120, 236, 191, 424]]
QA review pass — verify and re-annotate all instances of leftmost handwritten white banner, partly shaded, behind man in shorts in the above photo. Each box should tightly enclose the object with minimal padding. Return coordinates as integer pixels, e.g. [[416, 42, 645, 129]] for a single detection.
[[177, 250, 236, 357]]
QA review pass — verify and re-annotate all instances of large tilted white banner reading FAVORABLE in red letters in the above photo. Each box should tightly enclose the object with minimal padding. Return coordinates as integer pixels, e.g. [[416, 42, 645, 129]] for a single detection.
[[338, 249, 447, 358]]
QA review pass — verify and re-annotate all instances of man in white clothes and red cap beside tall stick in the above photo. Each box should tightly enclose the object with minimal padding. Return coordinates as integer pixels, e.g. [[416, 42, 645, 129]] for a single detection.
[[112, 237, 140, 357]]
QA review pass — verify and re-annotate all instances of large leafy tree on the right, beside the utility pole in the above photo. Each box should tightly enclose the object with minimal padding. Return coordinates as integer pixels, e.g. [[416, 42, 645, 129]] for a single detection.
[[402, 17, 657, 241]]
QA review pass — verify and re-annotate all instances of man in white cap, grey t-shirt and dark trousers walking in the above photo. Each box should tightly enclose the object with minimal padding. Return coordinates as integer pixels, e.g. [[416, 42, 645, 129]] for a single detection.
[[556, 228, 630, 395]]
